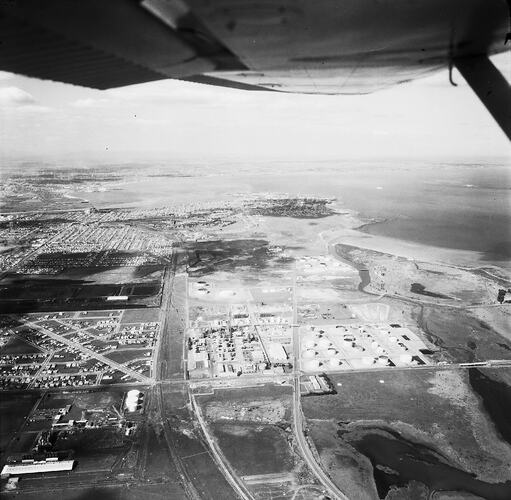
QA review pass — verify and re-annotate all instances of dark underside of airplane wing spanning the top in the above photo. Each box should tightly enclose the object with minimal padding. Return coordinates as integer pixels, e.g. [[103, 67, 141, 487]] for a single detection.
[[0, 0, 511, 136]]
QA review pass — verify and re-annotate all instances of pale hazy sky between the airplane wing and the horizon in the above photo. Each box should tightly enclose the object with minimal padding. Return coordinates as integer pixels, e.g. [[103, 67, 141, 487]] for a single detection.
[[0, 52, 511, 163]]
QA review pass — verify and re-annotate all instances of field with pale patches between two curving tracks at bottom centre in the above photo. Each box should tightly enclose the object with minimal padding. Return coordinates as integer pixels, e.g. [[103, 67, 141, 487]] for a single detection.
[[196, 384, 321, 500]]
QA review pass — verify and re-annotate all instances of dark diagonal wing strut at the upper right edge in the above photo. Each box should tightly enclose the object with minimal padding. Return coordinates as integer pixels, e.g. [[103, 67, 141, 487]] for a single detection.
[[454, 55, 511, 141]]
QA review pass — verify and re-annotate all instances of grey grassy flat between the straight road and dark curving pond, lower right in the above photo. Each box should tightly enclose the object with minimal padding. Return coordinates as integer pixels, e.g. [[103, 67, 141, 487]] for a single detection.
[[303, 370, 511, 482]]
